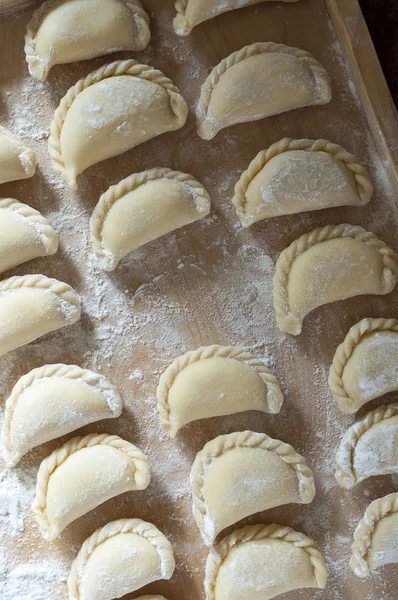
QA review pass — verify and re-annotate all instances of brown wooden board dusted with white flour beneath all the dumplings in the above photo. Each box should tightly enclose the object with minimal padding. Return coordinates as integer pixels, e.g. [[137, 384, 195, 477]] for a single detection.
[[0, 0, 398, 600]]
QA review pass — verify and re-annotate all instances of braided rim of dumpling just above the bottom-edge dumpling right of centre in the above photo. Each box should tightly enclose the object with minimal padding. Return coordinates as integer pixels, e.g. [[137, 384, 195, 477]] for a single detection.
[[190, 431, 315, 543]]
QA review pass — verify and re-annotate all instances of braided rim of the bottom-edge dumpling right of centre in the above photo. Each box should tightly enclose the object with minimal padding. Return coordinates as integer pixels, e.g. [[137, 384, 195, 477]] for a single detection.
[[205, 524, 327, 600]]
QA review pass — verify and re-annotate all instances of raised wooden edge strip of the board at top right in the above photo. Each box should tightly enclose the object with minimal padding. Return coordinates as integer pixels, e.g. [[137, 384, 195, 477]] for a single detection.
[[325, 0, 398, 196]]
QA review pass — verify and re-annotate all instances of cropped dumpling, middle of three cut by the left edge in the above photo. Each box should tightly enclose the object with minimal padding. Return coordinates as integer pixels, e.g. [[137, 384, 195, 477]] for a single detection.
[[0, 199, 58, 273]]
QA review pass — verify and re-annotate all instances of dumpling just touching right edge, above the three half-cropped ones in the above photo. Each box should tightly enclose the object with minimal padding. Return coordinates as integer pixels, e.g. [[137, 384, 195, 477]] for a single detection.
[[274, 223, 398, 335]]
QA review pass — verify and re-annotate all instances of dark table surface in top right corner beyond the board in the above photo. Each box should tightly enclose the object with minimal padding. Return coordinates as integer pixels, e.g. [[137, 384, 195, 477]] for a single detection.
[[359, 0, 398, 107]]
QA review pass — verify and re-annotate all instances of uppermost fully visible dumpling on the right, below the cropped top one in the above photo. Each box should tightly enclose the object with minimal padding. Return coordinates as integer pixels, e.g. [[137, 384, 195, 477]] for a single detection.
[[196, 42, 332, 140]]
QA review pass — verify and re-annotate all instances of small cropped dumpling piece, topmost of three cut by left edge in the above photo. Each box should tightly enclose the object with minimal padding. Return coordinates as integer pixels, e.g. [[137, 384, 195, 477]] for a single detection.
[[0, 126, 36, 184]]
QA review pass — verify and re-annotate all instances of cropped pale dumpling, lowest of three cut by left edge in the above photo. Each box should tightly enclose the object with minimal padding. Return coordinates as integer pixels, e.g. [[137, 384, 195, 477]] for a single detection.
[[0, 275, 81, 356]]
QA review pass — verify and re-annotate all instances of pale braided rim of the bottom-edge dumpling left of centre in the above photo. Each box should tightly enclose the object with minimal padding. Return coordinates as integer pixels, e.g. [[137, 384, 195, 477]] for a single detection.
[[68, 519, 175, 600]]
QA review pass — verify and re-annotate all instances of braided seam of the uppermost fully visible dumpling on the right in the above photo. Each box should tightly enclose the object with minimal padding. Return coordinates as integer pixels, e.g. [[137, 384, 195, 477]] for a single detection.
[[196, 42, 329, 139]]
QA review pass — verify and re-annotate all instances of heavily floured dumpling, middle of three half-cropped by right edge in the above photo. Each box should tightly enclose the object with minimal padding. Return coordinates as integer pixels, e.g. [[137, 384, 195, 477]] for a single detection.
[[336, 404, 398, 490]]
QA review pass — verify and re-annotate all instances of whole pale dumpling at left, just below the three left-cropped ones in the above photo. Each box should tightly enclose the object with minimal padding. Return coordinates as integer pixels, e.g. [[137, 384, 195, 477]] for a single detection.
[[2, 364, 123, 465]]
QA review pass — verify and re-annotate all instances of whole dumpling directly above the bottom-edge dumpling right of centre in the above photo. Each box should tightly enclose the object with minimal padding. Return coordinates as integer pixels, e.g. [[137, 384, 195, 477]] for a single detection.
[[190, 431, 315, 545]]
